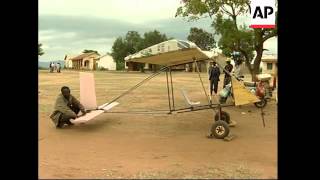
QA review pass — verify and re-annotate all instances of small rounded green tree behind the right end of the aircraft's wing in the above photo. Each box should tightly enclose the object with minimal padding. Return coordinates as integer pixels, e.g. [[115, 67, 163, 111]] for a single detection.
[[188, 27, 216, 51]]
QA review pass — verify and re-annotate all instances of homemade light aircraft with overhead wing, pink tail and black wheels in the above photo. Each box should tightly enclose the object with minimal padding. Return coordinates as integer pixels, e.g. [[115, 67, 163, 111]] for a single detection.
[[73, 40, 260, 139]]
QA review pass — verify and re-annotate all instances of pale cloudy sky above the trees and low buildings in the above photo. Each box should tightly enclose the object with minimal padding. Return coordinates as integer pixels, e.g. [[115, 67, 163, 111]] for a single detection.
[[38, 0, 277, 61]]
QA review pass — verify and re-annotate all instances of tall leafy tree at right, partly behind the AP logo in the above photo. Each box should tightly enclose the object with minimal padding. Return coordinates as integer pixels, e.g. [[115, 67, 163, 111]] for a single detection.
[[176, 0, 278, 80]]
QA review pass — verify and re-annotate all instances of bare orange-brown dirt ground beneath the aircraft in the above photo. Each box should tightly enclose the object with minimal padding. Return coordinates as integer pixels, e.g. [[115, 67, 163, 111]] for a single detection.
[[38, 70, 277, 179]]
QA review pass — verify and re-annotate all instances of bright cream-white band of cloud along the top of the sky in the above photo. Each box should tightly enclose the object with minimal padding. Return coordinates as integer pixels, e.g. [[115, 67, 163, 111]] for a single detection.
[[39, 0, 180, 23]]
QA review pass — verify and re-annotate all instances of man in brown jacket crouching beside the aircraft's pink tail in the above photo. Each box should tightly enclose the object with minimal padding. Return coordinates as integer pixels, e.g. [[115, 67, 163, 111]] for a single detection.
[[50, 86, 86, 128]]
